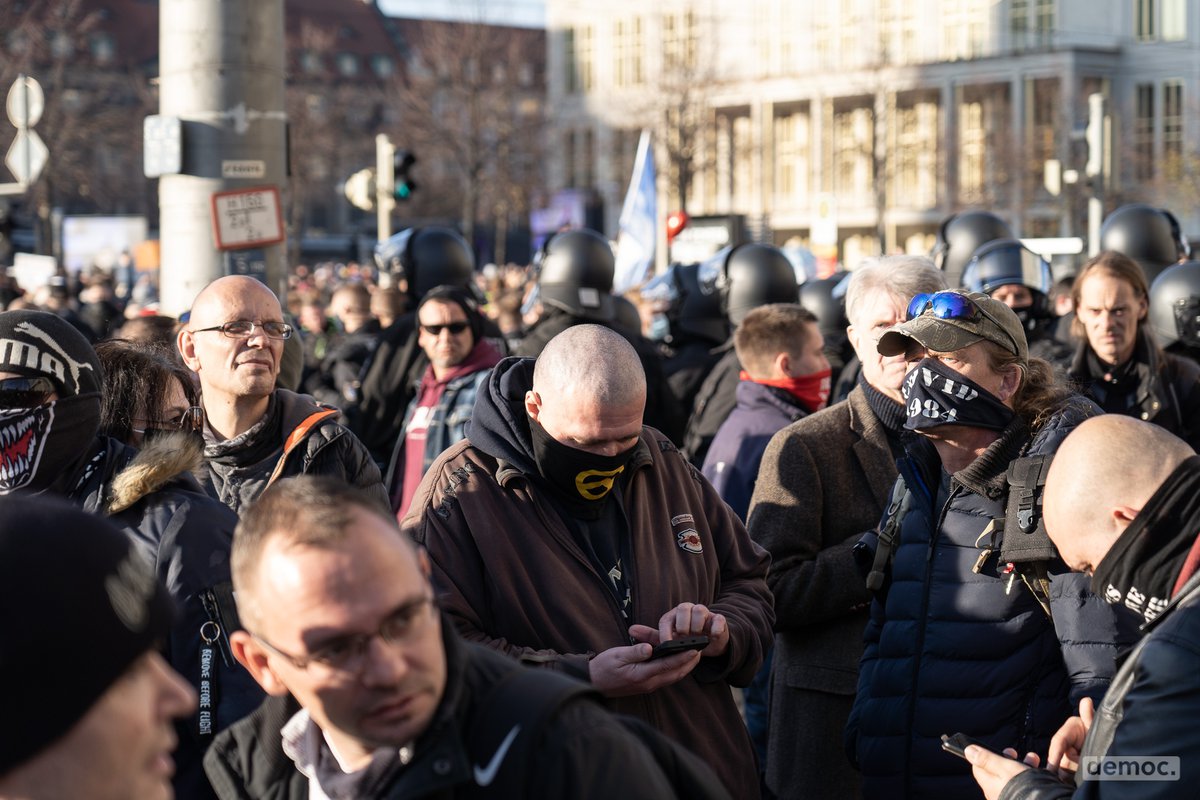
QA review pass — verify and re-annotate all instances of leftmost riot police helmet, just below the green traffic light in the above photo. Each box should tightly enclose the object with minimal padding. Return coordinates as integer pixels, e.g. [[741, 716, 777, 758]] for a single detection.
[[374, 225, 475, 305]]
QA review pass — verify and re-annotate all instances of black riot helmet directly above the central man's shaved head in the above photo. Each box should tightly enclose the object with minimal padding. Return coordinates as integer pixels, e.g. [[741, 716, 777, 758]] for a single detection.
[[534, 228, 616, 321]]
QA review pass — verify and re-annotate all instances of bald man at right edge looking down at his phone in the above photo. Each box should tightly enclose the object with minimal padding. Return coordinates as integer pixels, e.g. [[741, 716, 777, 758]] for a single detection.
[[966, 414, 1200, 800]]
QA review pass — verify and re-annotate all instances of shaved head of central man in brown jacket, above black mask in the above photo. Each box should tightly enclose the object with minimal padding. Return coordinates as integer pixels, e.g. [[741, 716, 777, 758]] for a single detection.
[[526, 325, 646, 456]]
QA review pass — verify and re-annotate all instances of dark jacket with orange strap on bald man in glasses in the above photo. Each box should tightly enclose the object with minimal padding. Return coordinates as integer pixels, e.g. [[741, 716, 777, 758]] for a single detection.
[[202, 389, 388, 512]]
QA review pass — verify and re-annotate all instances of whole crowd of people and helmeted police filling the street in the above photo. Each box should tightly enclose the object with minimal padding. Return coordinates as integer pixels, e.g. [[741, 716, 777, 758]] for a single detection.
[[0, 206, 1200, 800]]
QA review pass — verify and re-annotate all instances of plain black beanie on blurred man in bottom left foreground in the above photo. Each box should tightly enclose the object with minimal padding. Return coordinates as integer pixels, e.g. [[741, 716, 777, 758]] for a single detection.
[[0, 493, 172, 775]]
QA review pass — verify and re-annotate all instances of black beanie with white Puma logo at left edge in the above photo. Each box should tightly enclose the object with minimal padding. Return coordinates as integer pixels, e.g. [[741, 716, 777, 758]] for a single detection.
[[0, 309, 102, 397]]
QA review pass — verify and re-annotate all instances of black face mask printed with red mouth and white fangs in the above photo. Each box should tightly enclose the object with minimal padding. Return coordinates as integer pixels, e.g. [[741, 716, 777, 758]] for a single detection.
[[0, 395, 100, 494]]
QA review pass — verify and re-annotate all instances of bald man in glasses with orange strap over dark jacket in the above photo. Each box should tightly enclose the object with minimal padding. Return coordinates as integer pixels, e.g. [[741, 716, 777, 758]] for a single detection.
[[175, 275, 386, 512]]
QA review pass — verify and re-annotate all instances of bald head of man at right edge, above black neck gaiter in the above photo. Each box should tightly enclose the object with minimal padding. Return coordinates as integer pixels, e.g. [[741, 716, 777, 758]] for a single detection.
[[1044, 414, 1195, 572]]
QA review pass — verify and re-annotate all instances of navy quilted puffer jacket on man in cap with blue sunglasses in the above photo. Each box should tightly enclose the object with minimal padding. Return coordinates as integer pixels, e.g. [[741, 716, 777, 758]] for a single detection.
[[846, 397, 1134, 800]]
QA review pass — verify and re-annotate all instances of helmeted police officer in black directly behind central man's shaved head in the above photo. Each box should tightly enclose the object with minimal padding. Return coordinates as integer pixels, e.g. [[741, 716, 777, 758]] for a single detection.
[[512, 228, 684, 444]]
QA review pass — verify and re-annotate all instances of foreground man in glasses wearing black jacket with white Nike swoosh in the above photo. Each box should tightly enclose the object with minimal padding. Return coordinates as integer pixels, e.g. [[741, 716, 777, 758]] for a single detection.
[[204, 475, 728, 800]]
